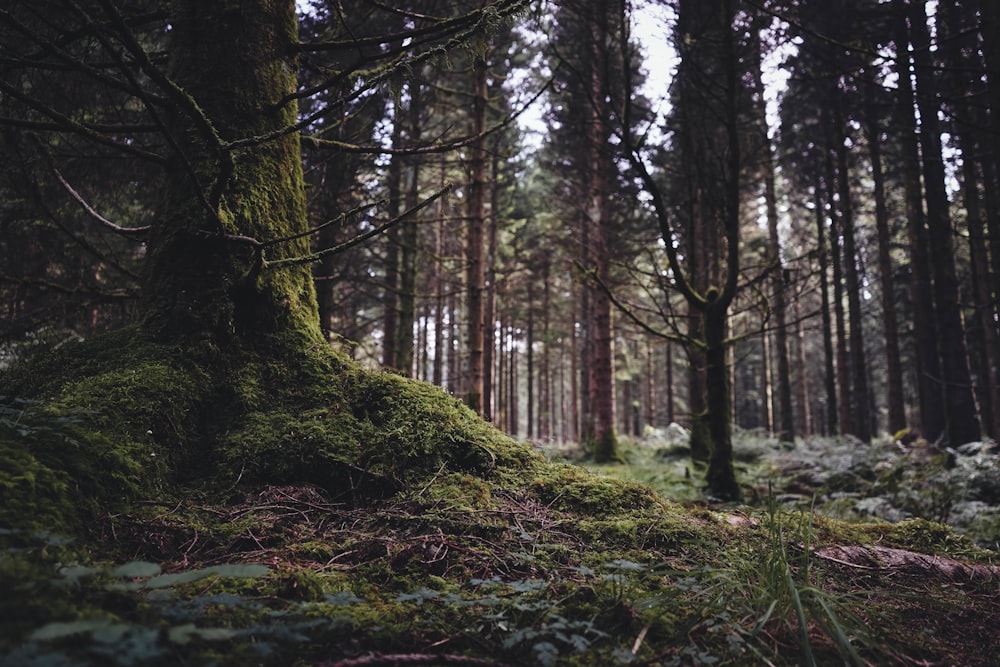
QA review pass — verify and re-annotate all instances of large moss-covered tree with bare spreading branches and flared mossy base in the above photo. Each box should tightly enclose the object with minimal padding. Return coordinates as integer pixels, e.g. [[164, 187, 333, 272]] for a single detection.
[[0, 0, 532, 502]]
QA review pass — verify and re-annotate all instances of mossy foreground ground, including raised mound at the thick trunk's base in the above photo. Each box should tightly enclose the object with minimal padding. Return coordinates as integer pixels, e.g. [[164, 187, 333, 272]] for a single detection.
[[0, 331, 1000, 666]]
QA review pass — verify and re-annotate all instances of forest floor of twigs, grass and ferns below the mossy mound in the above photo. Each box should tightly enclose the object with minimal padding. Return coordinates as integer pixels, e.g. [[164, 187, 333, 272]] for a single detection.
[[0, 414, 1000, 667]]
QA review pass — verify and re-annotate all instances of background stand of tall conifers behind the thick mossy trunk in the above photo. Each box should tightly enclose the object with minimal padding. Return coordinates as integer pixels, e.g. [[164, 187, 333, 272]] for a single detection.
[[0, 0, 1000, 490]]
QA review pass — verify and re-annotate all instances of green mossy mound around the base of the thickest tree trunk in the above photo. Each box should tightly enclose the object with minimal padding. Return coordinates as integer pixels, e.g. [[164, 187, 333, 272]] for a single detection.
[[0, 329, 541, 532]]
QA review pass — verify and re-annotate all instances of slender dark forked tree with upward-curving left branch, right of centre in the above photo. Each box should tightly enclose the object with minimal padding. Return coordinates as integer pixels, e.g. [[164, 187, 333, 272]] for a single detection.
[[620, 0, 743, 500]]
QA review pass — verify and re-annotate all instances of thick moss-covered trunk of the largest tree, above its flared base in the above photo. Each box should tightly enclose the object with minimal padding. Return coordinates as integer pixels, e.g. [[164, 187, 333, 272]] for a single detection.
[[145, 0, 322, 351]]
